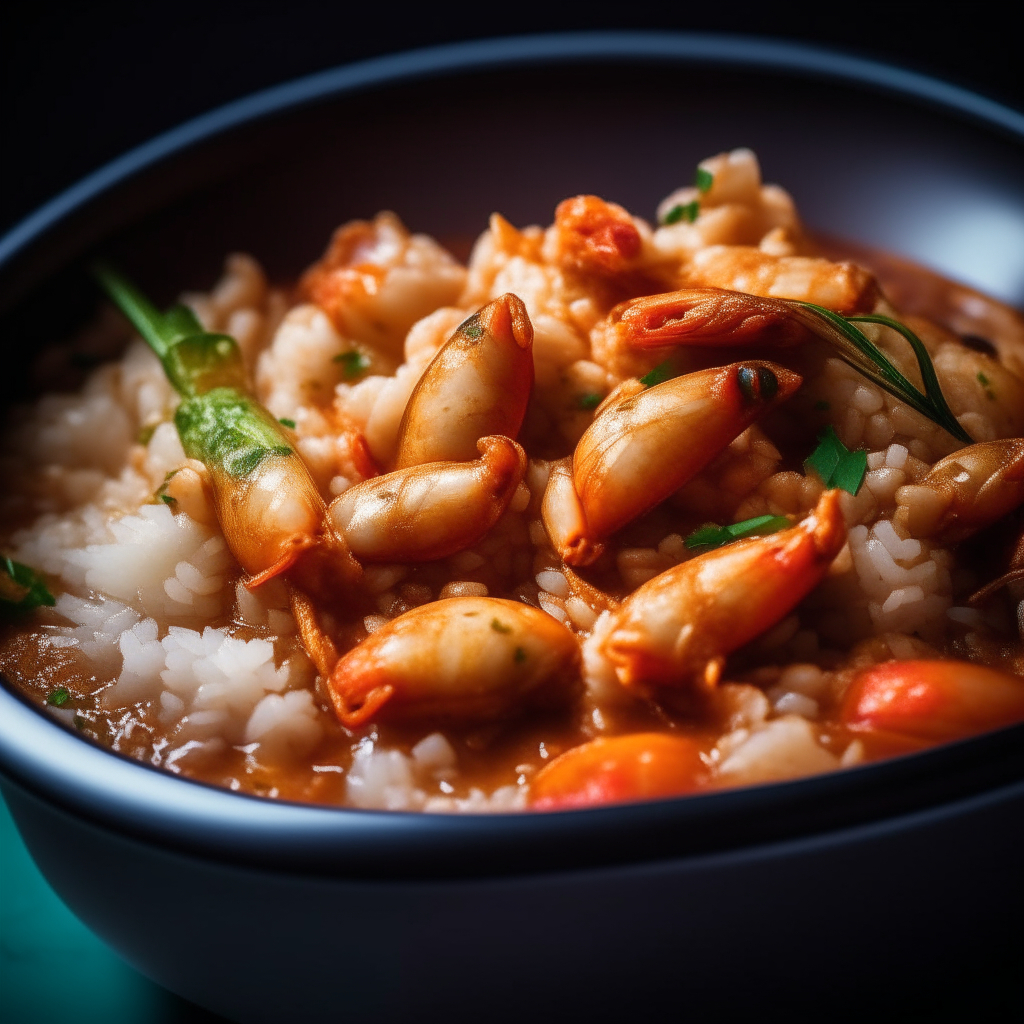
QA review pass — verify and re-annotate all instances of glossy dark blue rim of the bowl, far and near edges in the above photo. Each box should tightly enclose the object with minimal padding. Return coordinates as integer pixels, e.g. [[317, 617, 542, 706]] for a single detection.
[[6, 32, 1024, 879]]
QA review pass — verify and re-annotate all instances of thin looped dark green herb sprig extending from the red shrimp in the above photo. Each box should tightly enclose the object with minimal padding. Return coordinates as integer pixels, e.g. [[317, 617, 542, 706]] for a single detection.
[[786, 300, 974, 444]]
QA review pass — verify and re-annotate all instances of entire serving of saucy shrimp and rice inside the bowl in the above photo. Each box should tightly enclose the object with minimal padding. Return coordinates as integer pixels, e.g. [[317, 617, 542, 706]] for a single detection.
[[0, 150, 1024, 811]]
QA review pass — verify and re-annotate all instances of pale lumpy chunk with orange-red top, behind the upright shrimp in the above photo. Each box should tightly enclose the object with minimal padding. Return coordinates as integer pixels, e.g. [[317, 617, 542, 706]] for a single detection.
[[299, 213, 466, 360]]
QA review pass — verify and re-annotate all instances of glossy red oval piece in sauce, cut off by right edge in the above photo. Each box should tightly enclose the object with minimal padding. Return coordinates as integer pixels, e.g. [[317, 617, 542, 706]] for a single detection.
[[842, 662, 1024, 743]]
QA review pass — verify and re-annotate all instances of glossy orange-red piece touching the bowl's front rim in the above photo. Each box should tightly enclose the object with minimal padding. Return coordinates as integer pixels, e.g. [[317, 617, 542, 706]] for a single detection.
[[530, 732, 708, 811]]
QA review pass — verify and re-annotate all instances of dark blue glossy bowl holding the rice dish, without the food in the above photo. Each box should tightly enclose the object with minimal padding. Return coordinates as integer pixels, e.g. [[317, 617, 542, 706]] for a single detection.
[[0, 34, 1024, 1022]]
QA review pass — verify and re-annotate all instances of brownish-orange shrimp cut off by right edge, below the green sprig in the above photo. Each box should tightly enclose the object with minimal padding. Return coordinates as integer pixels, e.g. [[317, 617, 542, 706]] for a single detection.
[[893, 437, 1024, 544]]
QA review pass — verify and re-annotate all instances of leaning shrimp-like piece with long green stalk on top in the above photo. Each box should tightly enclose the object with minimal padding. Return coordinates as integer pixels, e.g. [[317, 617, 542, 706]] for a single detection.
[[95, 264, 360, 596]]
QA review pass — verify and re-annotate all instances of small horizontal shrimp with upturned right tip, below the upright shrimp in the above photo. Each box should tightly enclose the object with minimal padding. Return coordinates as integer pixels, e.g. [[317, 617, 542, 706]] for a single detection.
[[330, 437, 526, 562]]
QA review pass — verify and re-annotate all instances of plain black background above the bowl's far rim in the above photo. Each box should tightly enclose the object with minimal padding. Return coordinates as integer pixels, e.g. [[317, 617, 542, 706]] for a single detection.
[[0, 0, 1024, 231]]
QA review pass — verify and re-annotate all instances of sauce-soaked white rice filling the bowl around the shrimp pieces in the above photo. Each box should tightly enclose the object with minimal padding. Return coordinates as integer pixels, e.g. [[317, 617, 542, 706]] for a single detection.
[[0, 150, 1024, 812]]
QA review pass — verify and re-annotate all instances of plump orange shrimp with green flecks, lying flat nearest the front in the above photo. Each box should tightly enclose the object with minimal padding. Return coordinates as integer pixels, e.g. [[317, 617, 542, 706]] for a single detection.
[[328, 597, 580, 728]]
